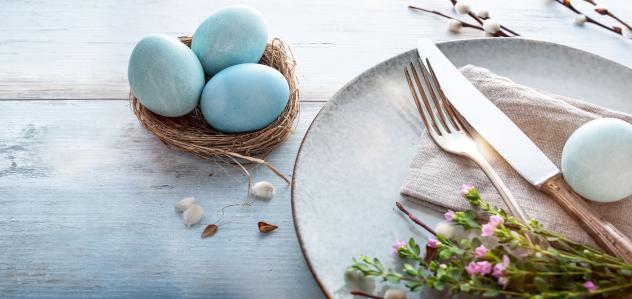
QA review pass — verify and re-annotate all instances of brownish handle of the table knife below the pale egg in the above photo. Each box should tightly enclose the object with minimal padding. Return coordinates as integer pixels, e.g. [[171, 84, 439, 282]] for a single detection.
[[540, 174, 632, 263]]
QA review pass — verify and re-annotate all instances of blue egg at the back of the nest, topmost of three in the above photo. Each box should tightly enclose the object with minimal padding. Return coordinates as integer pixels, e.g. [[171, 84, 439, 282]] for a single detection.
[[191, 5, 268, 76]]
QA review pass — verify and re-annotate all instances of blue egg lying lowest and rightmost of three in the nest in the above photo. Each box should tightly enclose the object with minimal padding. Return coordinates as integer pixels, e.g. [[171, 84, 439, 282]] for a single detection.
[[200, 63, 290, 133]]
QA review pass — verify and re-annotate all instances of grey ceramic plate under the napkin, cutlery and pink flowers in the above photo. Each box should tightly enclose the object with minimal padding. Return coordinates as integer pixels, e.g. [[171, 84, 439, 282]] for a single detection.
[[292, 38, 632, 298]]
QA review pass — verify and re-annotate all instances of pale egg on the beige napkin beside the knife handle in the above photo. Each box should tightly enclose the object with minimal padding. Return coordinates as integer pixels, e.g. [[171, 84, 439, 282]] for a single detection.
[[562, 118, 632, 202]]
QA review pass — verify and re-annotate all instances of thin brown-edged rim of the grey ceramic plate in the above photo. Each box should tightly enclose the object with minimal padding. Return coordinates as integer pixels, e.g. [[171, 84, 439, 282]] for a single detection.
[[290, 37, 632, 298]]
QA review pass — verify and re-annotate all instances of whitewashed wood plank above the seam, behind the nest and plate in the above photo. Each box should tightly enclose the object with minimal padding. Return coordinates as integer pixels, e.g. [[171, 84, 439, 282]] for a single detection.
[[0, 0, 632, 101]]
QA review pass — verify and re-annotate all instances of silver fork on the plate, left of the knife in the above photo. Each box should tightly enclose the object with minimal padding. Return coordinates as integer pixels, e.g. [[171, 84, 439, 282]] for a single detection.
[[404, 58, 528, 223]]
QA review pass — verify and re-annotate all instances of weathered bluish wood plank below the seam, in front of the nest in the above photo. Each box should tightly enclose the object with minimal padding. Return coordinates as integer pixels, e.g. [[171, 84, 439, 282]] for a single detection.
[[0, 100, 322, 298]]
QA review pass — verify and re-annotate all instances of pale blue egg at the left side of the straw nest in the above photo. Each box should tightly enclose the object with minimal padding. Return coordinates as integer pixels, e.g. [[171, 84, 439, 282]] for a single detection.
[[127, 34, 205, 117]]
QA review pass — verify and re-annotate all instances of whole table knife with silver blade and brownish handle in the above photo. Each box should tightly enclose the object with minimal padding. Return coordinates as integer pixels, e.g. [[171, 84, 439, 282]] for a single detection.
[[417, 39, 632, 263]]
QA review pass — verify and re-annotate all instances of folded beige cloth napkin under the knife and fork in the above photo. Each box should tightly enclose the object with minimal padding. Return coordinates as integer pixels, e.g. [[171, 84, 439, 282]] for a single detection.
[[401, 65, 632, 245]]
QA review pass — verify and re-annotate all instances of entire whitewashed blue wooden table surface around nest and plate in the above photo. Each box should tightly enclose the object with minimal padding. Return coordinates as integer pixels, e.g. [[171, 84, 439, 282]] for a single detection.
[[0, 0, 632, 298]]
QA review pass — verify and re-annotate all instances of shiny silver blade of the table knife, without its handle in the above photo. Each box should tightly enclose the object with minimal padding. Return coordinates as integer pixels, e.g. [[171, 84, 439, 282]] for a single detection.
[[417, 39, 560, 186]]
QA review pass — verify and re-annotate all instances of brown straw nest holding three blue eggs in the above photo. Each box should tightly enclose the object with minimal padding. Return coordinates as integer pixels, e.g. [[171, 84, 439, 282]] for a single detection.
[[130, 36, 299, 186]]
